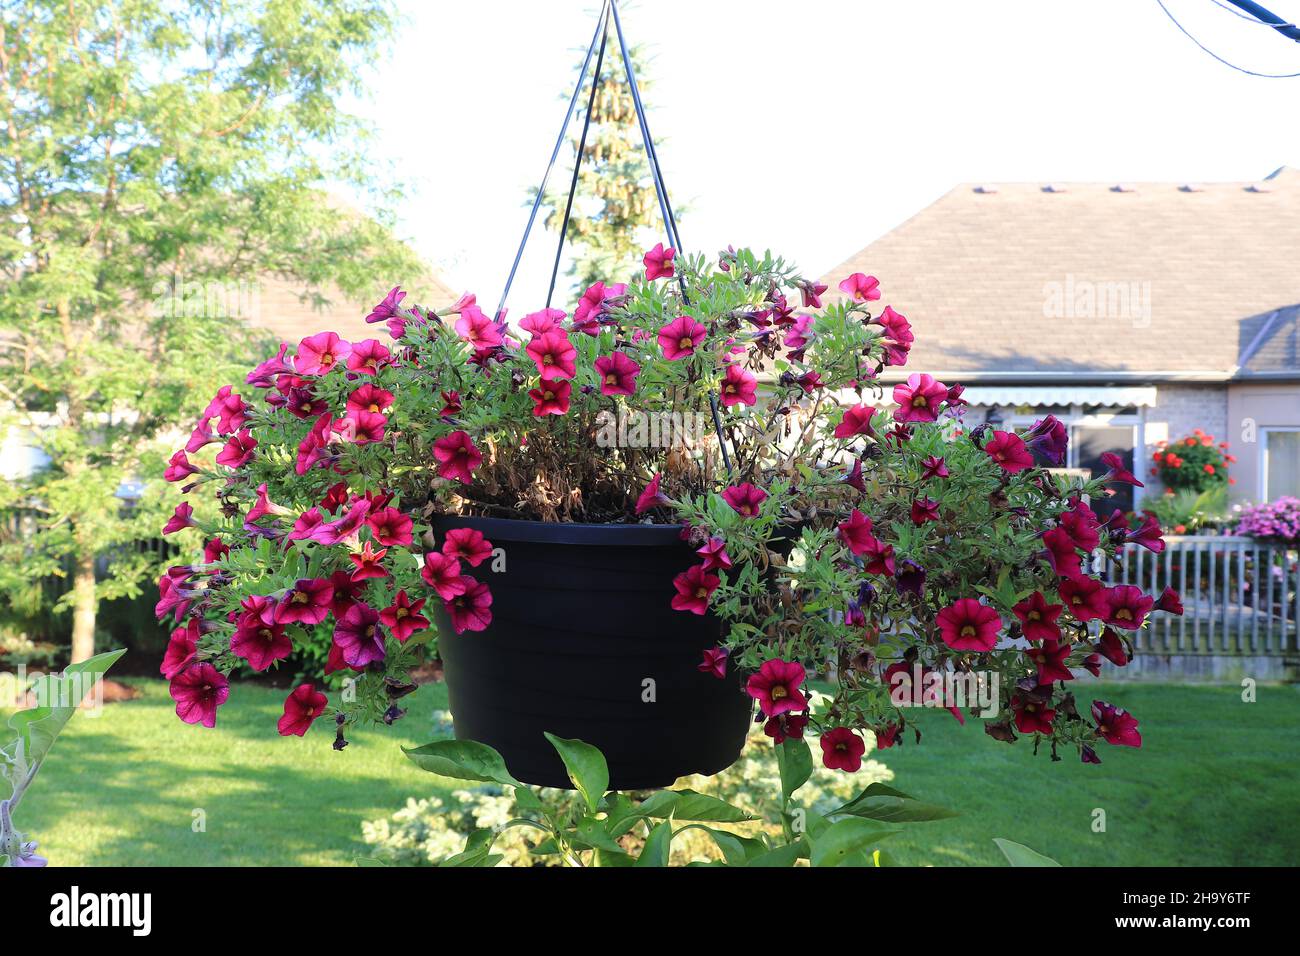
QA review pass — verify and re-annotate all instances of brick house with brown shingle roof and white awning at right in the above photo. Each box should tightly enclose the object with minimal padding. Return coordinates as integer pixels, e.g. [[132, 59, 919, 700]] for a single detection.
[[822, 168, 1300, 507]]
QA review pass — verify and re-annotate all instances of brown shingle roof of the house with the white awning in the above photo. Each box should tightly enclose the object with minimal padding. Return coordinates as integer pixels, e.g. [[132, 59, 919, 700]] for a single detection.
[[822, 168, 1300, 380]]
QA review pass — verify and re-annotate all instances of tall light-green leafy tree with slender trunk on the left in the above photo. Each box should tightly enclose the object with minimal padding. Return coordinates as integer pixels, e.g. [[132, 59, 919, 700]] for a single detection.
[[0, 0, 420, 661]]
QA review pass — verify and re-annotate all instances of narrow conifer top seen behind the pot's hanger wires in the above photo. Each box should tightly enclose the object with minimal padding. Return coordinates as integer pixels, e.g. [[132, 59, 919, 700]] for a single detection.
[[529, 34, 680, 293]]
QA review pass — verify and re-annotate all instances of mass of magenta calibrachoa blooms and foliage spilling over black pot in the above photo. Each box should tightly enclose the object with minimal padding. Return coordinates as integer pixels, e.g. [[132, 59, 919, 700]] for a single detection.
[[155, 243, 1180, 771]]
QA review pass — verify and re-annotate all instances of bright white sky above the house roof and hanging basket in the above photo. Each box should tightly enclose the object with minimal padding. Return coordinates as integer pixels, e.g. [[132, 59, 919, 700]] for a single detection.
[[345, 0, 1300, 306]]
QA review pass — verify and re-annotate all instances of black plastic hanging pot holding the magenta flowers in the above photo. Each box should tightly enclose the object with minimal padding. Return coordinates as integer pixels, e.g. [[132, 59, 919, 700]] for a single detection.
[[430, 516, 751, 790]]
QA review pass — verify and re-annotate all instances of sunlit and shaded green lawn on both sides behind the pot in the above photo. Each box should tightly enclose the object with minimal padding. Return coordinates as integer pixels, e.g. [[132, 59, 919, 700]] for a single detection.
[[10, 680, 1300, 866]]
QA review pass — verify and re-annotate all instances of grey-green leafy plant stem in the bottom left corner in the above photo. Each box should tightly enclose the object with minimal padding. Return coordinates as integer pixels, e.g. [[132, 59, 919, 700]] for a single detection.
[[0, 650, 126, 866]]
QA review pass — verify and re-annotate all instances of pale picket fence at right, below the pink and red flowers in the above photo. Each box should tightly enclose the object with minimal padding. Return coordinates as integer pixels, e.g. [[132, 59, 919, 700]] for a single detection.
[[1105, 535, 1300, 657]]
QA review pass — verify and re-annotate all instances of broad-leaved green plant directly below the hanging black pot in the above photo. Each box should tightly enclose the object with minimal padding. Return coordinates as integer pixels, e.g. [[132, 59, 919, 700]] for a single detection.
[[387, 734, 1052, 866]]
